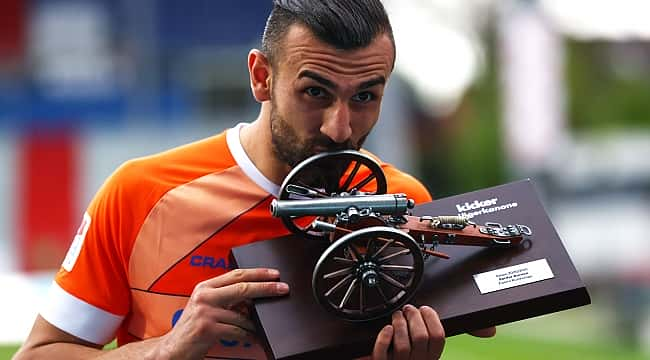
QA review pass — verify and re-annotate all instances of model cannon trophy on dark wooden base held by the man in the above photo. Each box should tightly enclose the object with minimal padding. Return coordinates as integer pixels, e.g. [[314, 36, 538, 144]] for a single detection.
[[232, 150, 590, 359]]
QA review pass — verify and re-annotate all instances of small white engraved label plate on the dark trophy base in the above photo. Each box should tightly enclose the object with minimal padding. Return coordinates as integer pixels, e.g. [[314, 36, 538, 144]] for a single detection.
[[474, 259, 554, 294]]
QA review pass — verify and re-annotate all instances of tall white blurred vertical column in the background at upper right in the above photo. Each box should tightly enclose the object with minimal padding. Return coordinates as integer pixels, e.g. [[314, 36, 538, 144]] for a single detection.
[[497, 1, 568, 174]]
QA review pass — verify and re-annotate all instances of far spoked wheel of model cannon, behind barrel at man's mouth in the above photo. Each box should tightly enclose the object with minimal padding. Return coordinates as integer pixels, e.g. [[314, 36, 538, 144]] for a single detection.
[[279, 150, 386, 239]]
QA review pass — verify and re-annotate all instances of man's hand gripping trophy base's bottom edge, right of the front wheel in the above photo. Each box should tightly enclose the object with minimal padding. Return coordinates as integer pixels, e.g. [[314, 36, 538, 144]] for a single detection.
[[372, 305, 445, 360]]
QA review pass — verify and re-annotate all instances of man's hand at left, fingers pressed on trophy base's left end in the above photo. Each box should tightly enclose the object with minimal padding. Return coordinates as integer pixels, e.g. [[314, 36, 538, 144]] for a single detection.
[[152, 269, 289, 359]]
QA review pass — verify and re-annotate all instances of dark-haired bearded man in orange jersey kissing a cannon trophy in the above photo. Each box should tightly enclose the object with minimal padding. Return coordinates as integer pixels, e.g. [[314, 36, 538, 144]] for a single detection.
[[17, 0, 493, 359]]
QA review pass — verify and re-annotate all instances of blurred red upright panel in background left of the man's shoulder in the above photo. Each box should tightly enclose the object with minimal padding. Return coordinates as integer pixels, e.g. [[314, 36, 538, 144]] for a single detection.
[[16, 130, 81, 271]]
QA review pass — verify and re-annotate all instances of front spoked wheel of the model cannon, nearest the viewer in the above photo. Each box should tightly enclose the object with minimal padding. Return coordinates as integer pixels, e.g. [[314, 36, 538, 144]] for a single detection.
[[312, 226, 424, 321]]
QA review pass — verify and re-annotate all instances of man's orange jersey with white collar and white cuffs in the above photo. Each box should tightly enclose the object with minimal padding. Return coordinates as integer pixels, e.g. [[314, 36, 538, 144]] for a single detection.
[[41, 124, 431, 358]]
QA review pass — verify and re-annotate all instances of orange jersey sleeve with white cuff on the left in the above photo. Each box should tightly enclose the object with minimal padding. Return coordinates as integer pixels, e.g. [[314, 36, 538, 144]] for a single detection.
[[41, 161, 144, 344]]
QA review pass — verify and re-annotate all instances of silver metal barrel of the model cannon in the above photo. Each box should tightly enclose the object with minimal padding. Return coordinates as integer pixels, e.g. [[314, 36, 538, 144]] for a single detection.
[[271, 194, 415, 217]]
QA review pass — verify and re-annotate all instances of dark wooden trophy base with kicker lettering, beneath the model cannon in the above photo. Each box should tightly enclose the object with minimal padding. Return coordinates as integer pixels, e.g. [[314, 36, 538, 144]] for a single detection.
[[231, 180, 590, 359]]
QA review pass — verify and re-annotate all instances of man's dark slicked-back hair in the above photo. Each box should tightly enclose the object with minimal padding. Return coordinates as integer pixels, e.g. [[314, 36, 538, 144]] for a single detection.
[[262, 0, 395, 64]]
